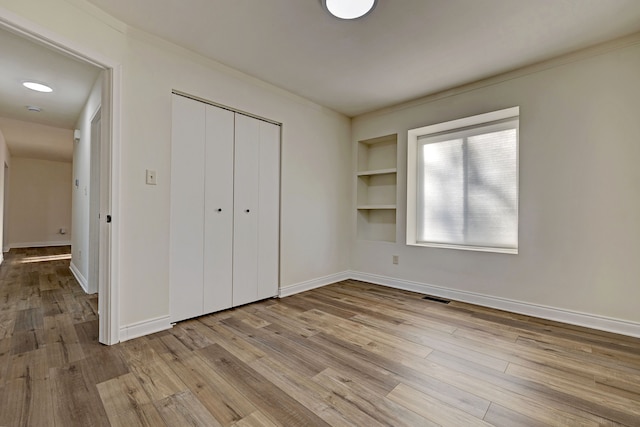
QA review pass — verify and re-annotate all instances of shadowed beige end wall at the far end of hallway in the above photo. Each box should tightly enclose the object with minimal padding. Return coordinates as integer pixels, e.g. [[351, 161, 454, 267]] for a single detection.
[[7, 157, 71, 248]]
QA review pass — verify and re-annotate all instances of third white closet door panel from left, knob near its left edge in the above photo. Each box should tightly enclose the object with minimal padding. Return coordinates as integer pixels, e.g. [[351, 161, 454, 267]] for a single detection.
[[233, 114, 260, 306]]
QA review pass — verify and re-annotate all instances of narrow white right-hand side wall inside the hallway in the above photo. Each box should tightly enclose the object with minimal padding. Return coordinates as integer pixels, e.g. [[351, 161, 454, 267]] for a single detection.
[[70, 75, 102, 288]]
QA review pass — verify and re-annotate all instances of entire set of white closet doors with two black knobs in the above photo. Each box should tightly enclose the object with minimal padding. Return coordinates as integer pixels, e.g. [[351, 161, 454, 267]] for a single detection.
[[169, 94, 280, 322]]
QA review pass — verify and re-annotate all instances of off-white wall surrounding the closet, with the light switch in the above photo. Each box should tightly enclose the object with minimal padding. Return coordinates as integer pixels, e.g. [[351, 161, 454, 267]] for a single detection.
[[0, 0, 351, 327]]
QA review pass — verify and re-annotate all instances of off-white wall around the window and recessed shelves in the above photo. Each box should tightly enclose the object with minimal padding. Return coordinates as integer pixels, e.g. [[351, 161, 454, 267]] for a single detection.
[[352, 41, 640, 333]]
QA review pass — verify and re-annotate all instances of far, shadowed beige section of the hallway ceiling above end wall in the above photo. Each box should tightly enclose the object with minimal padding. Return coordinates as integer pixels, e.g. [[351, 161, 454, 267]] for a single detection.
[[0, 117, 73, 162]]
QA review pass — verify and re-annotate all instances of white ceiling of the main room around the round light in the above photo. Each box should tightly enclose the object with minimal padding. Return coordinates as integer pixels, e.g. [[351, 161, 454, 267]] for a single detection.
[[89, 0, 640, 116]]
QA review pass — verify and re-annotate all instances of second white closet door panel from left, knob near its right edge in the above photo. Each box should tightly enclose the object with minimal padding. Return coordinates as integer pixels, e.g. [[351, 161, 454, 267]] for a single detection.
[[203, 105, 234, 313]]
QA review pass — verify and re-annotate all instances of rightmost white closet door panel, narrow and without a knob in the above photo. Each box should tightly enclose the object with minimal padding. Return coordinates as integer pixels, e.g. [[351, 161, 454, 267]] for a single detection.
[[257, 122, 280, 299]]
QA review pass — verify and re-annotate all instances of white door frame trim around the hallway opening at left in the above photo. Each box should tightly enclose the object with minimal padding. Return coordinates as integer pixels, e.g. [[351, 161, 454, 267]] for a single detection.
[[0, 7, 122, 345]]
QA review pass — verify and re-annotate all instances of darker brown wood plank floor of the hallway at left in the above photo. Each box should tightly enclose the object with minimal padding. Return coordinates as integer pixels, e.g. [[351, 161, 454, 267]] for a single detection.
[[0, 246, 115, 426]]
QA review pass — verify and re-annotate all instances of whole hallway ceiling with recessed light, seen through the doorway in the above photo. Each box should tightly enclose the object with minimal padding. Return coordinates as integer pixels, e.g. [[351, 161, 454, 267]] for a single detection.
[[0, 29, 100, 161]]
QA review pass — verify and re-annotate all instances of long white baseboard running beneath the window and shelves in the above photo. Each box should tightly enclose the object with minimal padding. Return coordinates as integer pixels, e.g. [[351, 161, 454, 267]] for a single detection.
[[351, 271, 640, 338]]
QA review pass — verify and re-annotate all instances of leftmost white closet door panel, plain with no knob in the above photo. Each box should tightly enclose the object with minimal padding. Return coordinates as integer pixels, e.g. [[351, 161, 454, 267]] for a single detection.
[[169, 95, 205, 322]]
